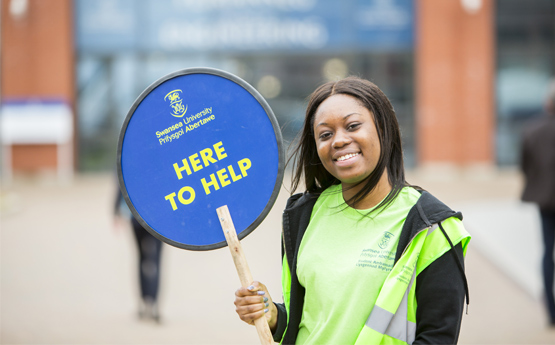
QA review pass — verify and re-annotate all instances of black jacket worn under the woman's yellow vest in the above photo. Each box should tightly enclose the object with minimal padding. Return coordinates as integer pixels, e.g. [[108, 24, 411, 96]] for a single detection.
[[274, 192, 468, 344]]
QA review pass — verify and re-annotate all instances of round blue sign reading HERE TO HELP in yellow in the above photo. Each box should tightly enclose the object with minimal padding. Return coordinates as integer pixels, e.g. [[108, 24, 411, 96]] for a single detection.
[[117, 68, 284, 250]]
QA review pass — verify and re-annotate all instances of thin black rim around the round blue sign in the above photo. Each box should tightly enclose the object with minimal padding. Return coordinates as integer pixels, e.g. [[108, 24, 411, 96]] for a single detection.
[[116, 67, 285, 251]]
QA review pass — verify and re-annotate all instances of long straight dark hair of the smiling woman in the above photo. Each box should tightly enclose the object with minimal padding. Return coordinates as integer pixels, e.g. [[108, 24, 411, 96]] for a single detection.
[[287, 77, 406, 210]]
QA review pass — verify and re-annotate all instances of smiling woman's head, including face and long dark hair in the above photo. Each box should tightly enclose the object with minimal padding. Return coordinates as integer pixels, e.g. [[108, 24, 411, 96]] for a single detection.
[[290, 77, 405, 208]]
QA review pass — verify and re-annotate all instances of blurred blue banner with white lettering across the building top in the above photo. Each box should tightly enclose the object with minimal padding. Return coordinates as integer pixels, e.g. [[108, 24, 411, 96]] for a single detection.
[[76, 0, 414, 53]]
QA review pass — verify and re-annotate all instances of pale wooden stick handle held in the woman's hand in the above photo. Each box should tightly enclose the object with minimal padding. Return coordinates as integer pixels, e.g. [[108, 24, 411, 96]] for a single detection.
[[216, 205, 274, 345]]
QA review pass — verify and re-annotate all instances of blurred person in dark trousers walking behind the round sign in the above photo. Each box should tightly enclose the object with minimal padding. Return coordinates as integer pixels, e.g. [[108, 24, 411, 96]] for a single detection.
[[114, 190, 162, 323]]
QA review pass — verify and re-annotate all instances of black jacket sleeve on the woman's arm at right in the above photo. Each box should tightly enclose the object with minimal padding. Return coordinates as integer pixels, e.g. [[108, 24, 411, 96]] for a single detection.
[[413, 243, 465, 344]]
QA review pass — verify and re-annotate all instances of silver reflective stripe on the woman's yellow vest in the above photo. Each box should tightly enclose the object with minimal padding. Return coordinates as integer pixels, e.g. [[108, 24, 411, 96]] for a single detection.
[[366, 271, 416, 344]]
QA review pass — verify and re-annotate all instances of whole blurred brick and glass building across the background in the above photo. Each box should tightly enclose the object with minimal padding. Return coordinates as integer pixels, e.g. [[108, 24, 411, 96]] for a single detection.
[[0, 0, 555, 177]]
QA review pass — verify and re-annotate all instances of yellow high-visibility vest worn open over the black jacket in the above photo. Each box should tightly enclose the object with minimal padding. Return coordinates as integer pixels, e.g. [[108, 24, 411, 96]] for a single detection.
[[281, 192, 470, 345]]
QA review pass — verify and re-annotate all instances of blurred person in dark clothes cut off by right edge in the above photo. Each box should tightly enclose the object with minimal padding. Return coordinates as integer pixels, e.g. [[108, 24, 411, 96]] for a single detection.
[[520, 80, 555, 327]]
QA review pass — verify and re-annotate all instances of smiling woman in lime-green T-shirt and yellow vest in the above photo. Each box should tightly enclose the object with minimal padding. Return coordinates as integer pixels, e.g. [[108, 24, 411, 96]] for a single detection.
[[235, 77, 470, 344]]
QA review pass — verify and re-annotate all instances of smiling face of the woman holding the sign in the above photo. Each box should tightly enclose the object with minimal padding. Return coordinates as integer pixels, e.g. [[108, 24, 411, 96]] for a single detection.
[[314, 94, 381, 187]]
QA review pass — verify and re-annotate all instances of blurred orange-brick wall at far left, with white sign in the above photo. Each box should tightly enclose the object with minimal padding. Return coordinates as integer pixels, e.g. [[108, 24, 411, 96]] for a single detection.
[[0, 0, 78, 181]]
